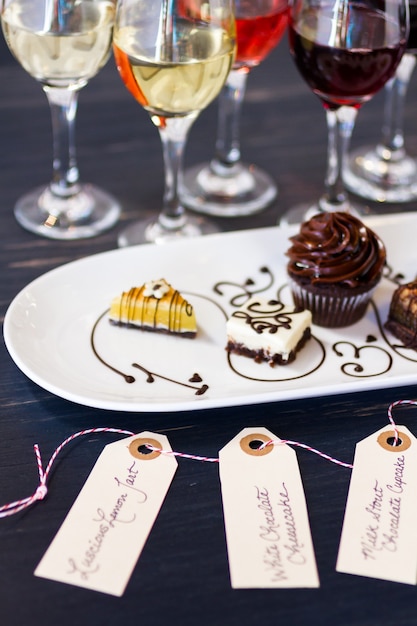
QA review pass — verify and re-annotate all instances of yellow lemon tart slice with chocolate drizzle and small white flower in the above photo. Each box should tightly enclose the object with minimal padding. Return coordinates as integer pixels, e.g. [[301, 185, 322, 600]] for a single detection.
[[109, 278, 197, 338]]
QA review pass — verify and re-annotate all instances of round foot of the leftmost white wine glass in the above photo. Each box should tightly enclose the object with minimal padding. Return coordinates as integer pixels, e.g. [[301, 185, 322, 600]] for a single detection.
[[14, 184, 121, 240]]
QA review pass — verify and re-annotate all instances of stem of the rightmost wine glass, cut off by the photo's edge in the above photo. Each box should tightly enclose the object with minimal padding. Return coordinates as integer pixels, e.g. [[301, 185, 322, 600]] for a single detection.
[[377, 53, 416, 161]]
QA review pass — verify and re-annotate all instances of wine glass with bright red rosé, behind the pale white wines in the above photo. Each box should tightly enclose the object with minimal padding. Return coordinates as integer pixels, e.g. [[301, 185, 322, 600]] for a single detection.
[[181, 0, 288, 217]]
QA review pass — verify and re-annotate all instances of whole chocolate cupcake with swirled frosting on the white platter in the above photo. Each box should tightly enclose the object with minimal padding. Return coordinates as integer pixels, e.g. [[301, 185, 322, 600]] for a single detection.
[[287, 212, 386, 328]]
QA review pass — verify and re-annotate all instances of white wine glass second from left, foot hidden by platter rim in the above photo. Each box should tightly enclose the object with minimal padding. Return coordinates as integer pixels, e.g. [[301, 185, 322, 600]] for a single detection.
[[113, 0, 236, 246]]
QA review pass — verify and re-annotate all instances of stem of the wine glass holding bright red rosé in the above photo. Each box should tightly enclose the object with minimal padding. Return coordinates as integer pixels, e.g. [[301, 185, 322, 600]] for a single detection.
[[211, 69, 248, 169]]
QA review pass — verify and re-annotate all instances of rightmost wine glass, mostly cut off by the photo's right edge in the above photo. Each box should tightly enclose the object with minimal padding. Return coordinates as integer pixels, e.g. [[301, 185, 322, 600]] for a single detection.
[[343, 2, 417, 203]]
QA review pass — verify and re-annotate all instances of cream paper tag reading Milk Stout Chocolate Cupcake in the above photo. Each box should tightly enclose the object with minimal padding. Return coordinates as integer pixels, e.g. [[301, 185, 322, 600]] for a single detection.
[[336, 426, 417, 585]]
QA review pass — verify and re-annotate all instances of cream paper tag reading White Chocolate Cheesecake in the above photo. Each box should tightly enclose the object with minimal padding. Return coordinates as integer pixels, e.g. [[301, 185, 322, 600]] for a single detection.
[[219, 428, 319, 589]]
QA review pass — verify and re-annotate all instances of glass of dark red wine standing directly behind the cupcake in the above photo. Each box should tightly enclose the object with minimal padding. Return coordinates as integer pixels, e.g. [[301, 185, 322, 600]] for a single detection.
[[282, 0, 408, 223]]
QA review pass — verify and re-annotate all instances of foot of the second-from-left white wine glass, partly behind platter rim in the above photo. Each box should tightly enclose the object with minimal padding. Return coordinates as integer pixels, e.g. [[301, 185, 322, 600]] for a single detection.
[[117, 215, 220, 248]]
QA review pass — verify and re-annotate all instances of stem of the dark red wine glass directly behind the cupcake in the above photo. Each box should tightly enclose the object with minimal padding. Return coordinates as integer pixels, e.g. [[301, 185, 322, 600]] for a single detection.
[[319, 106, 357, 211]]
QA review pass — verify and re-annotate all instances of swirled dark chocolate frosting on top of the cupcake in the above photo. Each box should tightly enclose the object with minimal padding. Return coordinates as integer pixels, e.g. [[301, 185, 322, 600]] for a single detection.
[[287, 212, 386, 289]]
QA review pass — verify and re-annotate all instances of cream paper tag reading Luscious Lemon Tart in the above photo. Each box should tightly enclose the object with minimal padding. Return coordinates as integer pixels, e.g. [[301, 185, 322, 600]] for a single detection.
[[35, 432, 177, 596]]
